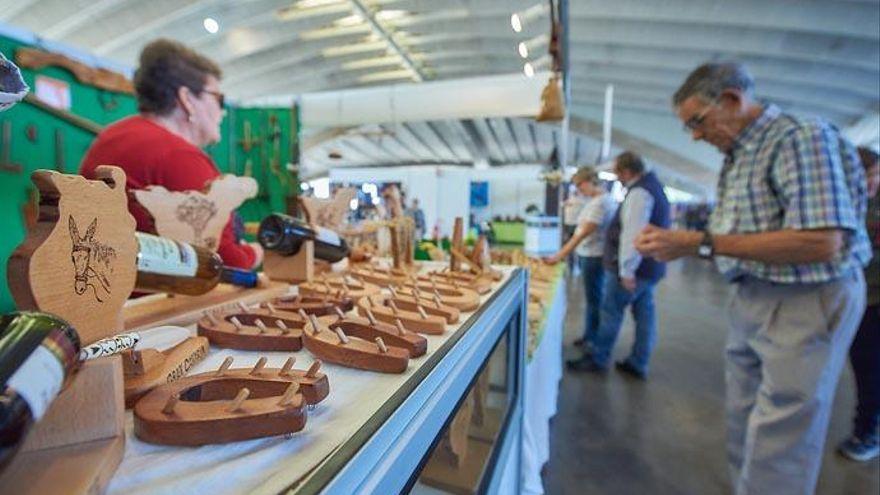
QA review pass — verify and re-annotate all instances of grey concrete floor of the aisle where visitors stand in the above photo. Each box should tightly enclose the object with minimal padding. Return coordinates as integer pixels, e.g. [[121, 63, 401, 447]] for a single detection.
[[544, 260, 880, 495]]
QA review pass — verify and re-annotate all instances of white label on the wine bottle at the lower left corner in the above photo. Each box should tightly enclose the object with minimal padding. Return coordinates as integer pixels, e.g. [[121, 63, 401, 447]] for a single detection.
[[7, 346, 64, 421]]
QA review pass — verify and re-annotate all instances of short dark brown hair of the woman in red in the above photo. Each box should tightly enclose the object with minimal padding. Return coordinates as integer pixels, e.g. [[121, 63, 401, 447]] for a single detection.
[[134, 39, 222, 115]]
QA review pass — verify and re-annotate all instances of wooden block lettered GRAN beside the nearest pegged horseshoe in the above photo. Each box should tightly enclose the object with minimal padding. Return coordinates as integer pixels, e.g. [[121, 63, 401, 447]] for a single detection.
[[122, 337, 208, 408]]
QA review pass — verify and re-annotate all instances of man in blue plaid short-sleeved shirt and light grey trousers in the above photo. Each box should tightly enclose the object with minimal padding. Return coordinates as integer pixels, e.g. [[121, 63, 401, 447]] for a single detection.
[[636, 63, 876, 495]]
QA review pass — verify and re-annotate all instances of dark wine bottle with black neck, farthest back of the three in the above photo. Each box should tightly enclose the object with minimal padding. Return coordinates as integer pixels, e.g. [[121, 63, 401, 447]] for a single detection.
[[257, 213, 349, 263]]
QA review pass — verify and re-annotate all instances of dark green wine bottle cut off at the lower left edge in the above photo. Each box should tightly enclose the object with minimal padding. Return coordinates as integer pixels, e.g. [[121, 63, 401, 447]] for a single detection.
[[0, 312, 80, 472]]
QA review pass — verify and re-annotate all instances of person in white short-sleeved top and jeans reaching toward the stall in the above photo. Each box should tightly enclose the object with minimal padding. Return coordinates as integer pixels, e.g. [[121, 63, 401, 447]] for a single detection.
[[544, 167, 617, 360]]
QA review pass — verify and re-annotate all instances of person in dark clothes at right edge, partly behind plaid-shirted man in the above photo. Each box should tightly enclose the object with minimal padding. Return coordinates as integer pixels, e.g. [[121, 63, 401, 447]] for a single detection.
[[838, 148, 880, 461]]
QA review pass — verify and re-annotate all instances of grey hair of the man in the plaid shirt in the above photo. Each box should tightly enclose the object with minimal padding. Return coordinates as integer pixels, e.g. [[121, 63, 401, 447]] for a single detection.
[[672, 62, 755, 107]]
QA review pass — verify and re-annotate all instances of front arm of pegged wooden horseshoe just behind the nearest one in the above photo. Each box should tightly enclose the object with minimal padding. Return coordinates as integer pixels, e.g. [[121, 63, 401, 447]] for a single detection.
[[303, 316, 410, 373]]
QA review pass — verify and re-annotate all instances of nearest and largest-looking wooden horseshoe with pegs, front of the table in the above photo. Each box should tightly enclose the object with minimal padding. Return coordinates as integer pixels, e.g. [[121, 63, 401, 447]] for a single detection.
[[134, 358, 329, 446]]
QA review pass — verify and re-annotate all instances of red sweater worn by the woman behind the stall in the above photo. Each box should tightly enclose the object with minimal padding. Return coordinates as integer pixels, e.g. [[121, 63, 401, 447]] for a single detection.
[[80, 116, 257, 269]]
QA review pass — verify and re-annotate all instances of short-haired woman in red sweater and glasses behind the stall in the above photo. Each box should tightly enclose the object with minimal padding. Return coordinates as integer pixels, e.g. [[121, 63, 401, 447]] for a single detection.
[[80, 39, 263, 269]]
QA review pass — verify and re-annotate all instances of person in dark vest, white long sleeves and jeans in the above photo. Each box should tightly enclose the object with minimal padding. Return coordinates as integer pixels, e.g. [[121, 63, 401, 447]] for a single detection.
[[568, 151, 669, 379]]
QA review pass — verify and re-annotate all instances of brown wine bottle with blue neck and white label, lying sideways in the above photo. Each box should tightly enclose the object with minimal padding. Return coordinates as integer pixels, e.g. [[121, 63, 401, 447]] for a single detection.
[[135, 232, 256, 296]]
